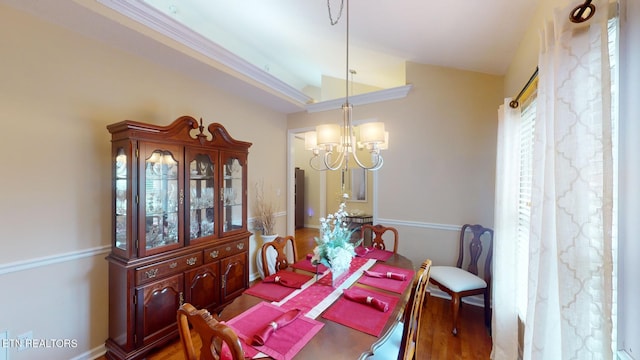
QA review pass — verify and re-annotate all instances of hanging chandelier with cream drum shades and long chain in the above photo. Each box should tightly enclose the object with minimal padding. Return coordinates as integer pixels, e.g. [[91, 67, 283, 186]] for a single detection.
[[304, 0, 389, 171]]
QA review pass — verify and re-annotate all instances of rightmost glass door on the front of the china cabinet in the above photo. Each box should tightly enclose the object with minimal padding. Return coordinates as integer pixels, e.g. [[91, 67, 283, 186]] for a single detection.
[[220, 155, 246, 233]]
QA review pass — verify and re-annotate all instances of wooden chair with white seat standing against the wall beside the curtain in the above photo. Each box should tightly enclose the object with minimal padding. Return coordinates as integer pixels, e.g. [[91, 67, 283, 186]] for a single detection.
[[430, 224, 493, 335]]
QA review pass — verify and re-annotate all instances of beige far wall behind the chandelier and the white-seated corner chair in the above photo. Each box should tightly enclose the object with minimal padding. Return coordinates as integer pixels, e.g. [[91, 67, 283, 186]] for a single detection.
[[288, 63, 504, 264]]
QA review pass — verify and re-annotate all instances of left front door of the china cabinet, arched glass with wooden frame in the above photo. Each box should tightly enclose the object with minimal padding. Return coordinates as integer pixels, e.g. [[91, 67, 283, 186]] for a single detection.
[[139, 146, 184, 255]]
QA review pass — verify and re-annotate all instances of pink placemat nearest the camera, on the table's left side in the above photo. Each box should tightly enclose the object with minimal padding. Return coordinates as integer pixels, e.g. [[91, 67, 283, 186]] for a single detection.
[[227, 302, 324, 360]]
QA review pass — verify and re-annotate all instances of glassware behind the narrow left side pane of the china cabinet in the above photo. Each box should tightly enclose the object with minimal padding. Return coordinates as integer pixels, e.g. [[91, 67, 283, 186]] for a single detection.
[[114, 148, 128, 250]]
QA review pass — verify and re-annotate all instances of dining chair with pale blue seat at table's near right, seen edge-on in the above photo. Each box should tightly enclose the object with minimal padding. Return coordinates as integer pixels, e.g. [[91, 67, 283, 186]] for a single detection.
[[367, 259, 431, 360]]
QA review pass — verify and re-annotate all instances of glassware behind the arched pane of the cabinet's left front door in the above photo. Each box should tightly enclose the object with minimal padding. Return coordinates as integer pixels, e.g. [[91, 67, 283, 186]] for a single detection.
[[145, 150, 179, 250]]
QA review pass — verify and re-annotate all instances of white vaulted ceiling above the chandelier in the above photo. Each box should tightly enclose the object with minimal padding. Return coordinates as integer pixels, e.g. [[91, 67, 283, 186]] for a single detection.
[[0, 0, 538, 112]]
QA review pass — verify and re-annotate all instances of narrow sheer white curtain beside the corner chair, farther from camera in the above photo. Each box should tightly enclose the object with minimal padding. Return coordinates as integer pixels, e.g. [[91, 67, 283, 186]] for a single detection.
[[491, 99, 520, 360]]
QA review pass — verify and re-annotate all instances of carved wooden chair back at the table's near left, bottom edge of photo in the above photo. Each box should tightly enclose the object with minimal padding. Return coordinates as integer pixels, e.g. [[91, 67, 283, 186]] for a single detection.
[[177, 303, 244, 360]]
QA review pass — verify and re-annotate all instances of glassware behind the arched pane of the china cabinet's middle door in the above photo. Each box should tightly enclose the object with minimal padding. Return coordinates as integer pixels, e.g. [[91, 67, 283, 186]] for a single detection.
[[188, 154, 215, 240]]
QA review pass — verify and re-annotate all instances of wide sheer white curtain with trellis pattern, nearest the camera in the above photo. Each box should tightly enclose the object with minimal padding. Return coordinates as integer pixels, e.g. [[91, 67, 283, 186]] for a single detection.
[[524, 0, 613, 360]]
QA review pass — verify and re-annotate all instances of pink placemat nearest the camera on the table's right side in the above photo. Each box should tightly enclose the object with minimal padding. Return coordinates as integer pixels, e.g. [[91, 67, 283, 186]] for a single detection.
[[322, 286, 399, 336]]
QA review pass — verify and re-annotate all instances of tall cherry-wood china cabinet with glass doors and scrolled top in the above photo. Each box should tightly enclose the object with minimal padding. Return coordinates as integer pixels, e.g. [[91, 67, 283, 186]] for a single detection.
[[106, 116, 251, 359]]
